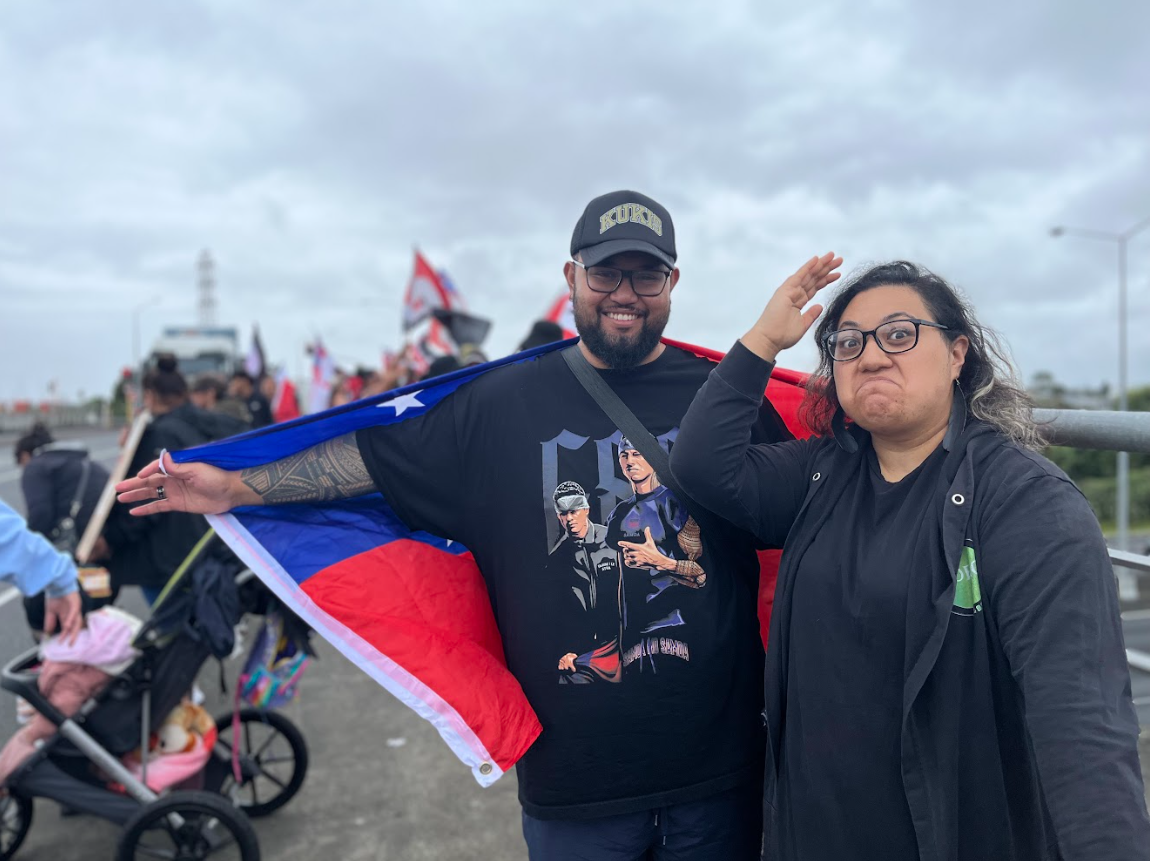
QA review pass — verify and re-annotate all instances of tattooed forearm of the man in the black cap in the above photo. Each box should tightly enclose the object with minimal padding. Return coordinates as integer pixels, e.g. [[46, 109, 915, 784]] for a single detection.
[[239, 433, 375, 505]]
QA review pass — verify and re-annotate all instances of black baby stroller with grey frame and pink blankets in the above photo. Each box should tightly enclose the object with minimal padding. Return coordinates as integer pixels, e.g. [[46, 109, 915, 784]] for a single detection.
[[0, 532, 307, 861]]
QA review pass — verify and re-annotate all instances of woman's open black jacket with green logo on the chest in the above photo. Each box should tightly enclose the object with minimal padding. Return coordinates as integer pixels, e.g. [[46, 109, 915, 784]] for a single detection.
[[672, 344, 1150, 861]]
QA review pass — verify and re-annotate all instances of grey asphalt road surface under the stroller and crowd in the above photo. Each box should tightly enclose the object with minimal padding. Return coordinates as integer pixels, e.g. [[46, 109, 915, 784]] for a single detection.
[[0, 431, 1150, 861]]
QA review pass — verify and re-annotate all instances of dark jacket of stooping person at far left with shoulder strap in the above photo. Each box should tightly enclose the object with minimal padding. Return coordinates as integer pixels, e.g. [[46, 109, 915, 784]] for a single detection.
[[21, 443, 108, 536]]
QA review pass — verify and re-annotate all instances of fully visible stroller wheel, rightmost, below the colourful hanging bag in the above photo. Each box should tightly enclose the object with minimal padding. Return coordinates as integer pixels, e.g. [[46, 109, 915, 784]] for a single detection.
[[214, 708, 307, 817]]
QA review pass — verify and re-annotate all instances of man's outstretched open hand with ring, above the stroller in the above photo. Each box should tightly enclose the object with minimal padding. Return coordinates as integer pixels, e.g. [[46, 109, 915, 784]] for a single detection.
[[116, 452, 257, 517]]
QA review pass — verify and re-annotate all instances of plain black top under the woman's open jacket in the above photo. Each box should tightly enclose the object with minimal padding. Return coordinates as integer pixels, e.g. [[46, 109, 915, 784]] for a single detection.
[[779, 446, 944, 861]]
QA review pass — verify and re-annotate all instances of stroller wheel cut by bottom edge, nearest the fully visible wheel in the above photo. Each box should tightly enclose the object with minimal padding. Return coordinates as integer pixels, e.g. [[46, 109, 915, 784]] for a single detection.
[[116, 792, 260, 861]]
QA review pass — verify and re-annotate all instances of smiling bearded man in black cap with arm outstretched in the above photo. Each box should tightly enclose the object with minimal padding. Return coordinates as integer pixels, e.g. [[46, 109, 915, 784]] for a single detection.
[[121, 191, 789, 861]]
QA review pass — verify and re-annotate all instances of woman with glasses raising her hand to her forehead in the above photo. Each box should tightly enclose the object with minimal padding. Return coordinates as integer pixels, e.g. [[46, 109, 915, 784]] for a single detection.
[[672, 254, 1150, 861]]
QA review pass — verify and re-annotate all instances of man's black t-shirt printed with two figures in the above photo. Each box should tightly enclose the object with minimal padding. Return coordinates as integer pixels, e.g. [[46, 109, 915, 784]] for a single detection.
[[359, 347, 789, 818]]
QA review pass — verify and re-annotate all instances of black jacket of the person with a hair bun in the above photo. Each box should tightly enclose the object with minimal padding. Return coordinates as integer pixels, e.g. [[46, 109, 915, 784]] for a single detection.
[[104, 402, 246, 587]]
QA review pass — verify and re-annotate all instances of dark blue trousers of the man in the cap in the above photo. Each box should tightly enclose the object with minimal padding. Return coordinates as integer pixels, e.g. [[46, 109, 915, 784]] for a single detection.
[[523, 783, 762, 861]]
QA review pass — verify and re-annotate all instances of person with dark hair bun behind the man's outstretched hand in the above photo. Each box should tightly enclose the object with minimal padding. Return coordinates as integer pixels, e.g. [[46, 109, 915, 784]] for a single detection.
[[104, 355, 247, 604]]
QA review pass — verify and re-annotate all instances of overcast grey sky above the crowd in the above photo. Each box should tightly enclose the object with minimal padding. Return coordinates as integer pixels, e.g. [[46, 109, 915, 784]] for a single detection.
[[0, 0, 1150, 401]]
